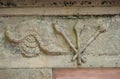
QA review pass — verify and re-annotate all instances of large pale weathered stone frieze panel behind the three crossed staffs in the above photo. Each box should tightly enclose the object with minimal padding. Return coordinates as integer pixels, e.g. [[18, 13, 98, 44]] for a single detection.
[[0, 15, 120, 68]]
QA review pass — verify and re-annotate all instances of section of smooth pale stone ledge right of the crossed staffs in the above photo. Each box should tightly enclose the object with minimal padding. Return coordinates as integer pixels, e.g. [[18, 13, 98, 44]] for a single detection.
[[80, 55, 120, 68]]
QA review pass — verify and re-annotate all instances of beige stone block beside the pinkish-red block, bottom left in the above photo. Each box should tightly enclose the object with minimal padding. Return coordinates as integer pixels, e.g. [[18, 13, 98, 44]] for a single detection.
[[0, 69, 52, 79]]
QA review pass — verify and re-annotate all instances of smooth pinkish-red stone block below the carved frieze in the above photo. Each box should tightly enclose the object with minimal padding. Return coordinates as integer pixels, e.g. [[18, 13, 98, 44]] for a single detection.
[[53, 68, 120, 79]]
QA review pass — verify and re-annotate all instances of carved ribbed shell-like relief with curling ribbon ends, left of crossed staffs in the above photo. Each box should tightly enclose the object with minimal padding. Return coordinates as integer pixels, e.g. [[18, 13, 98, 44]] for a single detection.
[[5, 21, 64, 57]]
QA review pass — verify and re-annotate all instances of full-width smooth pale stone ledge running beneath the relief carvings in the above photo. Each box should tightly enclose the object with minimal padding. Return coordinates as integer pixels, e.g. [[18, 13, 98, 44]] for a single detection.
[[0, 54, 120, 68]]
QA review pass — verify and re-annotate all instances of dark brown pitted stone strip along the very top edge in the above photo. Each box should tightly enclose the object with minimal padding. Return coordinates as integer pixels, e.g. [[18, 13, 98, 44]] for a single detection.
[[0, 0, 120, 7]]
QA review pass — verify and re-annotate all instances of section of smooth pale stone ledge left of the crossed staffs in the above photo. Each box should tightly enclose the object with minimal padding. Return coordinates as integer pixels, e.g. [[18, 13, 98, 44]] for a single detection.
[[0, 55, 77, 68]]
